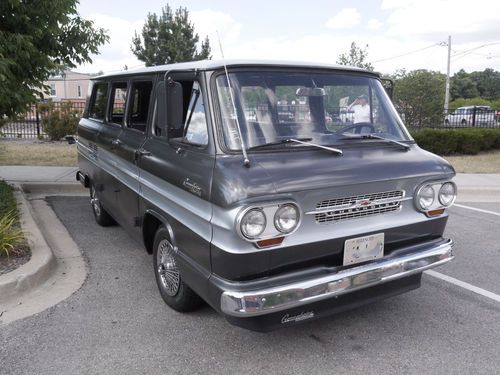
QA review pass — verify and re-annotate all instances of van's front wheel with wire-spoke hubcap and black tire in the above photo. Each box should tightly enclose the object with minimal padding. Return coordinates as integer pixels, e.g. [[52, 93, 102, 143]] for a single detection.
[[153, 227, 203, 312]]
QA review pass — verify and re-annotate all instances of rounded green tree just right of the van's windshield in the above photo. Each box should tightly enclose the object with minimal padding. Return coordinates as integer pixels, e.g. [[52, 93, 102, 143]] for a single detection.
[[393, 69, 446, 128]]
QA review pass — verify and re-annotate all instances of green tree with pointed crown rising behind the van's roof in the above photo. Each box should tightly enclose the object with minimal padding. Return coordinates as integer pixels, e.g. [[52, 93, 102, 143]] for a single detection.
[[131, 5, 211, 66]]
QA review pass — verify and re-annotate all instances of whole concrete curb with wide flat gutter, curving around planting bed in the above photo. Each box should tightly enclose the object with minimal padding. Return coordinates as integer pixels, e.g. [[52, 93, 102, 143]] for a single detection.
[[0, 187, 88, 326]]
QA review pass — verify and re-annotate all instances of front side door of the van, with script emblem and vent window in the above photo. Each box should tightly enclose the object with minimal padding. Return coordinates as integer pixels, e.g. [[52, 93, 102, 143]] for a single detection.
[[139, 72, 215, 295]]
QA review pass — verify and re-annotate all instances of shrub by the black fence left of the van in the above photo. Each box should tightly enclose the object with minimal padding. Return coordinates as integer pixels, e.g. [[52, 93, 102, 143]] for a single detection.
[[39, 102, 80, 140]]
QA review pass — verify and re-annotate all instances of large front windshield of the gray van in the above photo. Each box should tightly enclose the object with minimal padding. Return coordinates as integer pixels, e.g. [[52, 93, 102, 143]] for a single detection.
[[216, 71, 411, 150]]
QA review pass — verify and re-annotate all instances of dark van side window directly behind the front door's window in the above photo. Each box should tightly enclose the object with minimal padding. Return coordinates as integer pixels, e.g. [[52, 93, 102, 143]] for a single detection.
[[127, 81, 153, 133]]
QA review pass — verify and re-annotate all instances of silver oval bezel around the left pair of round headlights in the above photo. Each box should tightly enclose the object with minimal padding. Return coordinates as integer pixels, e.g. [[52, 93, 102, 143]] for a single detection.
[[235, 201, 302, 243]]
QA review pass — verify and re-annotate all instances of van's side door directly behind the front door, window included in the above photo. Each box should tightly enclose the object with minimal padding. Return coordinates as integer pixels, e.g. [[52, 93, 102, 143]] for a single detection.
[[115, 77, 153, 238]]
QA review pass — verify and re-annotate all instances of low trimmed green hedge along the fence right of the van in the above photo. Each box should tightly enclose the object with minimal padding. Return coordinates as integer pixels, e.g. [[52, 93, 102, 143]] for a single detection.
[[412, 128, 500, 155]]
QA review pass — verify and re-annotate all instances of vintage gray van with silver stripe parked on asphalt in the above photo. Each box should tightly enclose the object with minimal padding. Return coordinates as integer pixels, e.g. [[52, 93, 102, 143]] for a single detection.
[[77, 61, 456, 331]]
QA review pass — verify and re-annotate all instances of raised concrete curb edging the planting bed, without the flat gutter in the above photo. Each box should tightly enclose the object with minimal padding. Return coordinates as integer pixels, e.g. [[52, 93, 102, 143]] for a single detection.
[[0, 191, 57, 302]]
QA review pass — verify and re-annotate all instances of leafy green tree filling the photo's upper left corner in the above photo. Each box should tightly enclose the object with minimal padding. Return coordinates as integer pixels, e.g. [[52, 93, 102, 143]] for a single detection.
[[0, 0, 108, 118]]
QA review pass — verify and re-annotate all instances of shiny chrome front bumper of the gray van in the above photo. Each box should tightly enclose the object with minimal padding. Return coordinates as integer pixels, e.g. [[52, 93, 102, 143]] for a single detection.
[[220, 240, 453, 318]]
